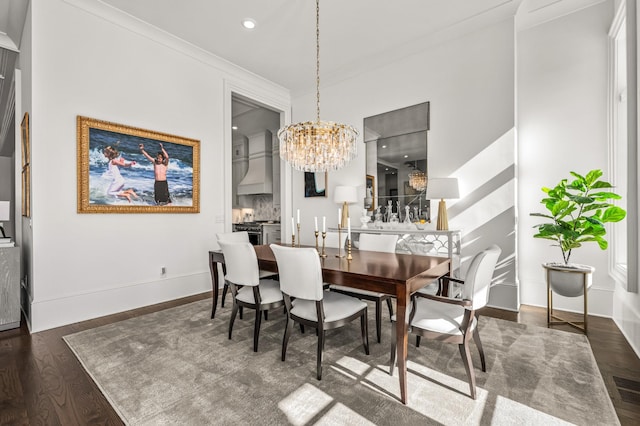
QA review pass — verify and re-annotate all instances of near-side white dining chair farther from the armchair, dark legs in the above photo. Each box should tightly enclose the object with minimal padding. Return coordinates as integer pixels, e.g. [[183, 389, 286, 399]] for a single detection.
[[219, 241, 284, 352]]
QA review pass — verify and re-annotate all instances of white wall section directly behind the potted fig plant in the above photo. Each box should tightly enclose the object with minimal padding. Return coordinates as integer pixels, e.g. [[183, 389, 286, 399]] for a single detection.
[[517, 1, 614, 316]]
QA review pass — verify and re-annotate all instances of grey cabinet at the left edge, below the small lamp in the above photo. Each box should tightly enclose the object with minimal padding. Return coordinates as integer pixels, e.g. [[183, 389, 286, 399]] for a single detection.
[[0, 247, 20, 331]]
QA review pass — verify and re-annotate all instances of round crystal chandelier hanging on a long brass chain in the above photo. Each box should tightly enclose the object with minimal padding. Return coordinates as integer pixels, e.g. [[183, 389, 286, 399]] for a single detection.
[[278, 0, 358, 172]]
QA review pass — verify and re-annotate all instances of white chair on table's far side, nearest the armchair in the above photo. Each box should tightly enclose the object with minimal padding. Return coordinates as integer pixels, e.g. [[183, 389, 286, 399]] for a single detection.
[[329, 234, 398, 343]]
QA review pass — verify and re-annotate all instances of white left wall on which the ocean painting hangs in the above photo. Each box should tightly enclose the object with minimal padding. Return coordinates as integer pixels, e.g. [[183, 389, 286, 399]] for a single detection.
[[27, 0, 288, 331]]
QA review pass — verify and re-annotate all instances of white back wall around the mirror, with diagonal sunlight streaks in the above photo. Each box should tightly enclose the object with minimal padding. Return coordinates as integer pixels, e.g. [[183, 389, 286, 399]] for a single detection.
[[290, 20, 517, 309]]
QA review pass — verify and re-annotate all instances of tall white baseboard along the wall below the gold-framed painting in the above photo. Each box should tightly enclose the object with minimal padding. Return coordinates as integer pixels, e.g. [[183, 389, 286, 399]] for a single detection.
[[31, 271, 211, 333]]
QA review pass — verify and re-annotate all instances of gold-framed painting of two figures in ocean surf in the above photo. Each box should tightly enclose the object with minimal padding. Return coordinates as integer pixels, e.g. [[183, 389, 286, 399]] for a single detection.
[[76, 116, 200, 213]]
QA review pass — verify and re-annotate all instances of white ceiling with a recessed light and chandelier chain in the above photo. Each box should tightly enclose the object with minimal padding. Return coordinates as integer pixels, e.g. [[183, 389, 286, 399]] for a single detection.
[[0, 0, 604, 155]]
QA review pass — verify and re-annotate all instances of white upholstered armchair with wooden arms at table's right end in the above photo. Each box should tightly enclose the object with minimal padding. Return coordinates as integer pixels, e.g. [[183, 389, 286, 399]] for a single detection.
[[389, 244, 501, 399]]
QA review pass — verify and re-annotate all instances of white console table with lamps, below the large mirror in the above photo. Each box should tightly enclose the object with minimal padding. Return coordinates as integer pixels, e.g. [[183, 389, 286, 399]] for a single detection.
[[329, 224, 462, 271]]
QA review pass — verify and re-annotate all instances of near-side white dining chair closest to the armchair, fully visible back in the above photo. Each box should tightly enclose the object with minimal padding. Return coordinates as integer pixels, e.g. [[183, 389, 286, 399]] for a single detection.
[[270, 244, 369, 380]]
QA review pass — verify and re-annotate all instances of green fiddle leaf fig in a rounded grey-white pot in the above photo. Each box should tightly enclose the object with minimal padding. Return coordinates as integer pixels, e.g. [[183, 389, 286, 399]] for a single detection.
[[531, 169, 626, 297]]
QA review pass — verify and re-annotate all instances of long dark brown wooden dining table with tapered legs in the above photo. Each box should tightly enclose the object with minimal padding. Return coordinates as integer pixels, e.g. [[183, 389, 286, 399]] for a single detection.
[[209, 245, 451, 404]]
